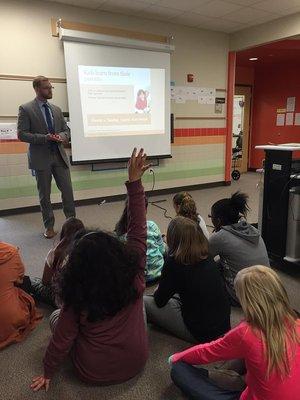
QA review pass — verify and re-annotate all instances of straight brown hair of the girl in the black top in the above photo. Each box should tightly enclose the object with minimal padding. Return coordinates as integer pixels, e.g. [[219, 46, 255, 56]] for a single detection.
[[167, 216, 208, 265]]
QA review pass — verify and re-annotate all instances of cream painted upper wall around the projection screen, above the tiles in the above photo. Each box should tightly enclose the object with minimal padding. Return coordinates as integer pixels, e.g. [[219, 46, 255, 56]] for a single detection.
[[0, 0, 229, 120]]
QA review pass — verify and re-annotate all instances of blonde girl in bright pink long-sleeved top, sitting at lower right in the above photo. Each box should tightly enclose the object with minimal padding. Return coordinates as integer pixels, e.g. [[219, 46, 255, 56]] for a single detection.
[[169, 266, 300, 400]]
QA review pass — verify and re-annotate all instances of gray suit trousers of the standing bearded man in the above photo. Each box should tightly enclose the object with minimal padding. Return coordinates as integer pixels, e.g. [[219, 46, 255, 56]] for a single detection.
[[35, 148, 75, 229]]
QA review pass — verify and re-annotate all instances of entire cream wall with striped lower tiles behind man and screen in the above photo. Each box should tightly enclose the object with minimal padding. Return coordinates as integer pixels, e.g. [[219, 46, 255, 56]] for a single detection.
[[0, 0, 229, 210]]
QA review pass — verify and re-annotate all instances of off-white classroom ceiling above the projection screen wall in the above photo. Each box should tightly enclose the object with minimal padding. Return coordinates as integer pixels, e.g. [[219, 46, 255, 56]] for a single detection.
[[43, 0, 300, 33]]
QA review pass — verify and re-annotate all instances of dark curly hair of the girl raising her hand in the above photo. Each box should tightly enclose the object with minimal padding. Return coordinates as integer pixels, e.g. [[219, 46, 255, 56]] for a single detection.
[[60, 231, 139, 322]]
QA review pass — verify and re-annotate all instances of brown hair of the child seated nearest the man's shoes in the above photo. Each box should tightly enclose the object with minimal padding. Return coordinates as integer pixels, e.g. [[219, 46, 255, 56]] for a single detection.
[[52, 217, 84, 271]]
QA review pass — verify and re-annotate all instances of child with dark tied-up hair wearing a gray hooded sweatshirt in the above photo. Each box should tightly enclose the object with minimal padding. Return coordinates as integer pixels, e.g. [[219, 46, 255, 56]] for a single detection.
[[209, 192, 270, 305]]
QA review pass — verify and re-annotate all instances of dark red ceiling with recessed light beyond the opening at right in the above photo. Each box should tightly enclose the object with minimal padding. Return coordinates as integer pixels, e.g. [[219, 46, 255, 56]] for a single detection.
[[236, 39, 300, 67]]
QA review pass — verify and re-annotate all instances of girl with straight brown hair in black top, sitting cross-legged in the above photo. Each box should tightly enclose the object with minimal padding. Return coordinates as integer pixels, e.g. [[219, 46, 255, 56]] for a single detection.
[[144, 216, 230, 343]]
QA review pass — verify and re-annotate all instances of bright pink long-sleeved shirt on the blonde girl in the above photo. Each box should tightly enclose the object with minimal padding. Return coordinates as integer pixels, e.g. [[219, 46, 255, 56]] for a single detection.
[[172, 320, 300, 400]]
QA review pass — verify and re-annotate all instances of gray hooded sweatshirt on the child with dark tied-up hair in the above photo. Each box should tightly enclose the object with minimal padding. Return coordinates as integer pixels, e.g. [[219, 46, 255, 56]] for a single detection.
[[209, 221, 270, 301]]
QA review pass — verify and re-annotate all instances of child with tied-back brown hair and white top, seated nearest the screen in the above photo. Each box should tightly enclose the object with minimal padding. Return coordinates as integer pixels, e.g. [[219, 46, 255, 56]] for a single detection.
[[173, 192, 209, 239]]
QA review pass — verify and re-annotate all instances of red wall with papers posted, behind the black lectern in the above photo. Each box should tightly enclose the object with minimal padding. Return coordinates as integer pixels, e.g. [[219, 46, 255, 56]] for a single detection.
[[249, 63, 300, 168]]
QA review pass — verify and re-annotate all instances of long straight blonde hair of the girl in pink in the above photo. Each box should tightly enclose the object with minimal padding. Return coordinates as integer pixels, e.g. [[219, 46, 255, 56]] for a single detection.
[[234, 265, 300, 377]]
